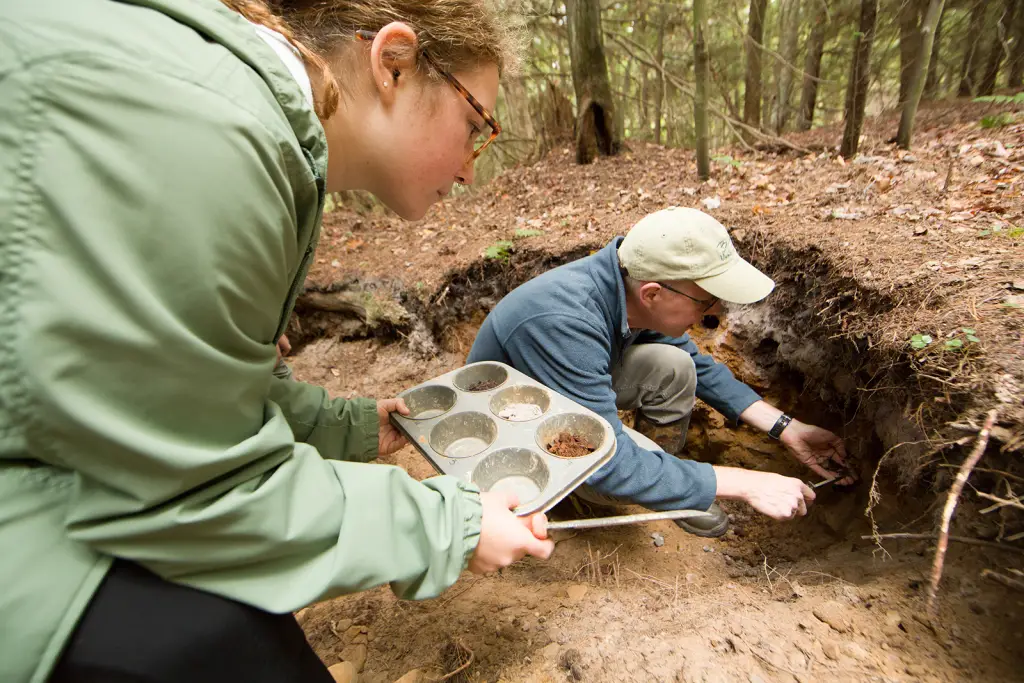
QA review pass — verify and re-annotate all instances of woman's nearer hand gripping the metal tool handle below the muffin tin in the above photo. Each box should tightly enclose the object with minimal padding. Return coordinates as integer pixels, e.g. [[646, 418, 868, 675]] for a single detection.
[[469, 494, 555, 573]]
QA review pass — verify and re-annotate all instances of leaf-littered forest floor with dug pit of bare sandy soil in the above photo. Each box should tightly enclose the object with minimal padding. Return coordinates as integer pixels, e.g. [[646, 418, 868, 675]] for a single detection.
[[290, 97, 1024, 683]]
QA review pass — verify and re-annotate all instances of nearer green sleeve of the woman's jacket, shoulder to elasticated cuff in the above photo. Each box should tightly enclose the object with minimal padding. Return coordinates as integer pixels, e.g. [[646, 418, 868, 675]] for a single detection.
[[16, 60, 480, 611]]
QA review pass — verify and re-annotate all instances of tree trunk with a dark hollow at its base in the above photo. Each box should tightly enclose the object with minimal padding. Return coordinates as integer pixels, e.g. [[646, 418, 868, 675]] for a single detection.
[[565, 0, 620, 164]]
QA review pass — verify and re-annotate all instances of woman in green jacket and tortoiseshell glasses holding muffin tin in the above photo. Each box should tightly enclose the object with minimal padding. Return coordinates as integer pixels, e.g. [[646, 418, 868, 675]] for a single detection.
[[0, 0, 552, 683]]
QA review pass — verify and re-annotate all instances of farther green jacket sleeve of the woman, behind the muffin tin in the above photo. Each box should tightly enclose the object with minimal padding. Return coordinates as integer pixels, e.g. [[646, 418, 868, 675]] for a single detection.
[[270, 377, 380, 463]]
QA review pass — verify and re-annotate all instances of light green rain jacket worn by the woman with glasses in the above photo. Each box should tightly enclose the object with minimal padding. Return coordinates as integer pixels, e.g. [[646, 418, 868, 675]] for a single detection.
[[0, 0, 480, 683]]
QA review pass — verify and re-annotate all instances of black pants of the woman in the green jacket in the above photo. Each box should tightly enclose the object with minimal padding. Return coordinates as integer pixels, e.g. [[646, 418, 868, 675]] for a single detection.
[[50, 561, 333, 683]]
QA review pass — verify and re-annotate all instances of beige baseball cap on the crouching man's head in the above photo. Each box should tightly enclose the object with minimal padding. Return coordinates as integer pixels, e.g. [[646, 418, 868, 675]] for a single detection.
[[618, 207, 775, 303]]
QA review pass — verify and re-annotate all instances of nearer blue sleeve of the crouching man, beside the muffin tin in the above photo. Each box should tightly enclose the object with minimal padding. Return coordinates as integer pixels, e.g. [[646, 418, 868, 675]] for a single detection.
[[503, 314, 717, 510]]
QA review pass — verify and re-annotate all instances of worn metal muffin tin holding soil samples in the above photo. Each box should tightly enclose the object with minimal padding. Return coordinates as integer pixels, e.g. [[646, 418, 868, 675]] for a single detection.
[[391, 361, 615, 515]]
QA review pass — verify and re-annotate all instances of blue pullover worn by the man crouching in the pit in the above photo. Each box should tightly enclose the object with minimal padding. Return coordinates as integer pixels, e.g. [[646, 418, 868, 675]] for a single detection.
[[468, 238, 760, 510]]
